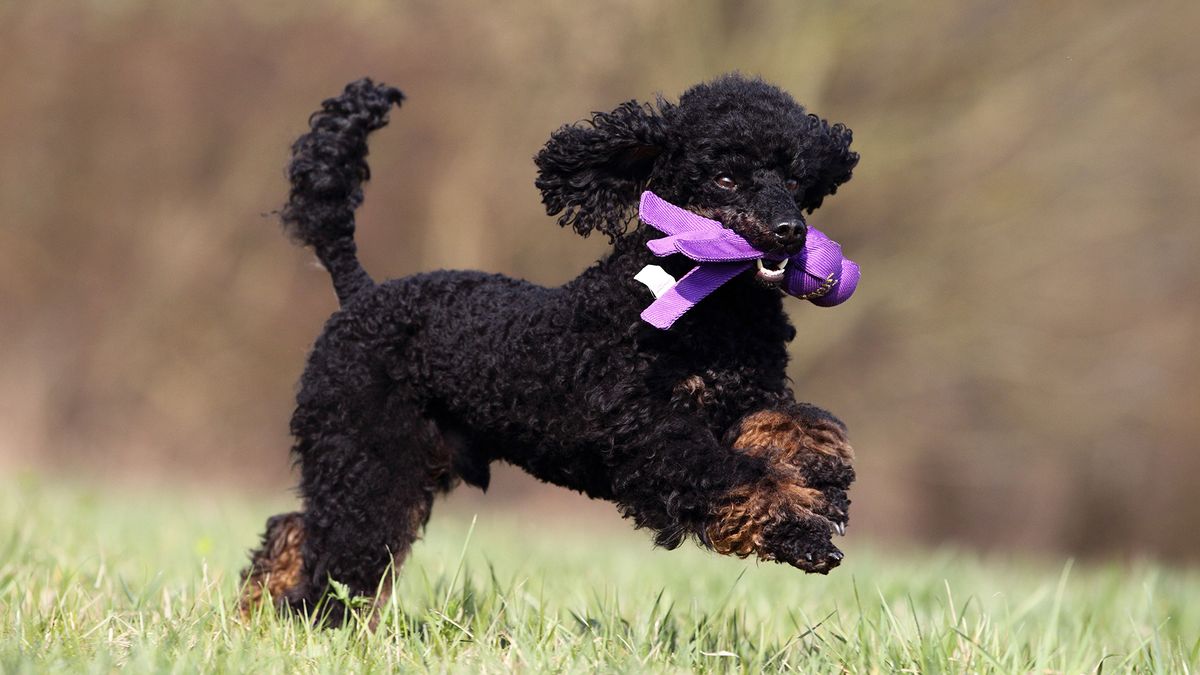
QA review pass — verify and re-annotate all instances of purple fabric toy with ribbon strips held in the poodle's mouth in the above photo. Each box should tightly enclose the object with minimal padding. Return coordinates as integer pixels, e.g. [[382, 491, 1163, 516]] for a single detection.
[[638, 190, 859, 330]]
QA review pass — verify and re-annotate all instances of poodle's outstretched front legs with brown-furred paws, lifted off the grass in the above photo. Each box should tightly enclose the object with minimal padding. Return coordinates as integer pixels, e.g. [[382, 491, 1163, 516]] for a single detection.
[[614, 405, 854, 573]]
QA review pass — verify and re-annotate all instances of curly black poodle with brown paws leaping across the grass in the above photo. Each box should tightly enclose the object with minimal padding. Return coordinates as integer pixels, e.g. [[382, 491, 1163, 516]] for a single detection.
[[242, 74, 858, 623]]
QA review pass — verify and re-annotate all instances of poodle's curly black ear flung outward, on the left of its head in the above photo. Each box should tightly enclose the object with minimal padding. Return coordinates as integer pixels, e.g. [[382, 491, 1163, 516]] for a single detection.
[[533, 101, 667, 240]]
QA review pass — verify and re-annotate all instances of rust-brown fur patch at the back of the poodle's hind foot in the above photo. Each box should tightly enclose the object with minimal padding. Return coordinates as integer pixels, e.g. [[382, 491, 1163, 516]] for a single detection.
[[239, 513, 306, 616]]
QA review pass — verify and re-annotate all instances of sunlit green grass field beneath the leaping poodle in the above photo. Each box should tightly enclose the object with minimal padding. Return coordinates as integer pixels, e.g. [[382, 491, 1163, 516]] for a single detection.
[[0, 477, 1200, 673]]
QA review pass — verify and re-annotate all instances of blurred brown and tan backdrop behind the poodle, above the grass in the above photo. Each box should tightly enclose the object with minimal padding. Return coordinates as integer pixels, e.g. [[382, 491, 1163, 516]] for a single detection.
[[0, 0, 1200, 560]]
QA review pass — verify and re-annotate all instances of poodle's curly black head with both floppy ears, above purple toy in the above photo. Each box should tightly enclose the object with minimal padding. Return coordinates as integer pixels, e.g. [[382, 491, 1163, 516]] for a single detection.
[[534, 74, 858, 253]]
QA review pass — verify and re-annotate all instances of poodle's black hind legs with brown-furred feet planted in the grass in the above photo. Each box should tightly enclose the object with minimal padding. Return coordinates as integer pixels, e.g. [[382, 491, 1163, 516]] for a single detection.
[[244, 330, 456, 625]]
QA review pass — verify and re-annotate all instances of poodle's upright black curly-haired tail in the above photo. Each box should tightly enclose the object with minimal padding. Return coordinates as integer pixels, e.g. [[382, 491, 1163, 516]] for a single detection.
[[281, 78, 404, 305]]
